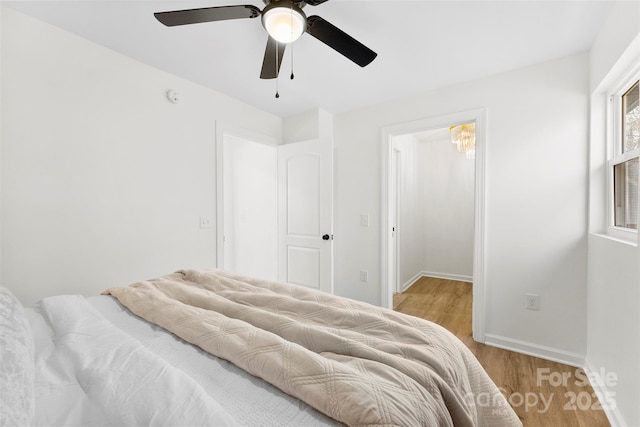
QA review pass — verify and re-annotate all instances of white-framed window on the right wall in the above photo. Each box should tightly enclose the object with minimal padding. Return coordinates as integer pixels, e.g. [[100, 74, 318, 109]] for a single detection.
[[610, 80, 640, 232]]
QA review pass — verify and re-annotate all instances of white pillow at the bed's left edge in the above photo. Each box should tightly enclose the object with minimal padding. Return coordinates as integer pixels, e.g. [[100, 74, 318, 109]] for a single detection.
[[0, 286, 34, 426]]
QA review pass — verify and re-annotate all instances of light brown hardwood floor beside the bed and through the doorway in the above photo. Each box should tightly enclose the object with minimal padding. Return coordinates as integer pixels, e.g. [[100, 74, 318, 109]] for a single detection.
[[393, 277, 610, 427]]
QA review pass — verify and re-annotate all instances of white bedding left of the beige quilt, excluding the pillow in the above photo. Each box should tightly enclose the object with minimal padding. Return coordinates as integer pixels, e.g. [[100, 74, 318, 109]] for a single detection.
[[27, 296, 338, 426]]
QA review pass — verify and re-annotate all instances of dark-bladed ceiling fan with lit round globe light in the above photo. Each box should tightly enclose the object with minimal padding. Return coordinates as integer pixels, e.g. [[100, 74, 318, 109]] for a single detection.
[[154, 0, 377, 79]]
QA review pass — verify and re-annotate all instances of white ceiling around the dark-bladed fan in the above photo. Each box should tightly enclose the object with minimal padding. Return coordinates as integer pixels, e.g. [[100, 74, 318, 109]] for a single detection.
[[2, 0, 612, 117]]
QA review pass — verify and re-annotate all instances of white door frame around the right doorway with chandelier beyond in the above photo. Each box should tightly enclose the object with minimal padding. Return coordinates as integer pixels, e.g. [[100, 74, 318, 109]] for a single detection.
[[380, 108, 487, 343]]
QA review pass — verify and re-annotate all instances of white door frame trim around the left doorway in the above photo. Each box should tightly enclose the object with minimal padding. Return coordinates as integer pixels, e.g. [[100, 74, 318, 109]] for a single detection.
[[215, 121, 279, 269]]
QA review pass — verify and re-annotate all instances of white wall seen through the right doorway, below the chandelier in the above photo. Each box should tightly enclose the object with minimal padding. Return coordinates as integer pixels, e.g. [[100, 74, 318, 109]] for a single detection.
[[393, 129, 474, 289]]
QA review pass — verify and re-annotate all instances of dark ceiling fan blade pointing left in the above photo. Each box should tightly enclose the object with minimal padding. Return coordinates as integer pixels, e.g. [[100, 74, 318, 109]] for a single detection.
[[153, 5, 261, 27]]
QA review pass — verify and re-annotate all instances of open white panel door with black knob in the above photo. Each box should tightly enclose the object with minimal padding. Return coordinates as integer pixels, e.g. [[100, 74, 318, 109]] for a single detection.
[[278, 139, 333, 293]]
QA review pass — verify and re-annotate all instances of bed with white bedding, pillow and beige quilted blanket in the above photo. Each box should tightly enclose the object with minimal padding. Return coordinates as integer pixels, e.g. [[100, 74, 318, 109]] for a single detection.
[[0, 270, 522, 427]]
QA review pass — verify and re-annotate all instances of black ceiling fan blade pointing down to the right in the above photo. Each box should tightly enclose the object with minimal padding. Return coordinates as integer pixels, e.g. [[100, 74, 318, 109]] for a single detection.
[[307, 16, 378, 67]]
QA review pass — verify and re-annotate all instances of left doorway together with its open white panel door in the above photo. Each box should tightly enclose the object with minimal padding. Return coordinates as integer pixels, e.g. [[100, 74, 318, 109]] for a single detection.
[[216, 125, 333, 293]]
